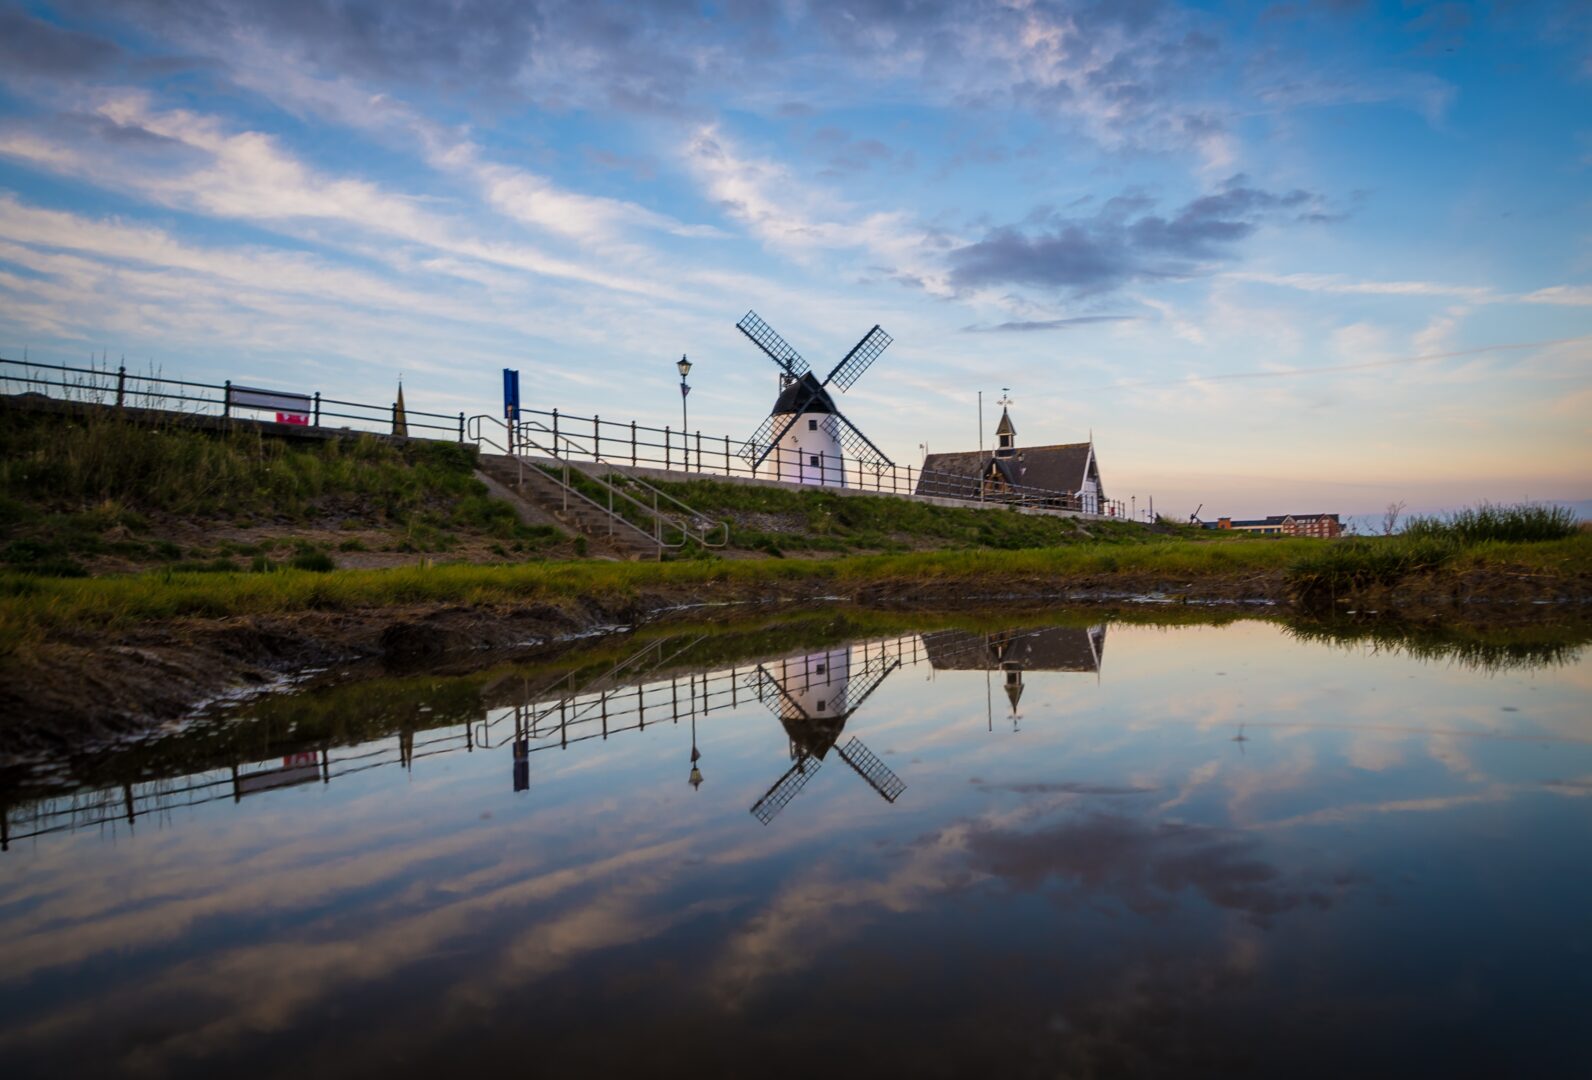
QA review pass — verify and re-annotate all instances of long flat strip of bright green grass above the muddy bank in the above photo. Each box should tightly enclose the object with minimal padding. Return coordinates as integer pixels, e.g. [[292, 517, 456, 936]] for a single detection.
[[0, 535, 1592, 653]]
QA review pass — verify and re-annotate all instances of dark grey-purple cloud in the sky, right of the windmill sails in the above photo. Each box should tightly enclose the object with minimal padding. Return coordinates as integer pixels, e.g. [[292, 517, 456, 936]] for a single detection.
[[949, 175, 1325, 293]]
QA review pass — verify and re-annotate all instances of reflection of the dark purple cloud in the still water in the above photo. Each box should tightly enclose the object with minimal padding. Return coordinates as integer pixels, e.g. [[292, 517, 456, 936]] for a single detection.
[[966, 812, 1334, 924]]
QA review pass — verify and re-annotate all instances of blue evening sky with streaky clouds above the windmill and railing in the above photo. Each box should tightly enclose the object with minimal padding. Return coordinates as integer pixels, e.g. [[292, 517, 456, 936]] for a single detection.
[[0, 0, 1592, 516]]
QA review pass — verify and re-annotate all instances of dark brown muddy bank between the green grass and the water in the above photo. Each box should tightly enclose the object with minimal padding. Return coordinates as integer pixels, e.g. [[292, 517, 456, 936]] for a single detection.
[[0, 572, 1592, 758]]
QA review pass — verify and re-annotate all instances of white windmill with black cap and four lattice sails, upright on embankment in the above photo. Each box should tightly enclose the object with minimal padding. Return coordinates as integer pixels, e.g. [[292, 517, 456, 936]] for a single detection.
[[736, 311, 893, 487]]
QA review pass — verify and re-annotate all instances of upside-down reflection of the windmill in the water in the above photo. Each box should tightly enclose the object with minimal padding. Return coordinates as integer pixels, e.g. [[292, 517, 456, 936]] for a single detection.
[[745, 648, 906, 825]]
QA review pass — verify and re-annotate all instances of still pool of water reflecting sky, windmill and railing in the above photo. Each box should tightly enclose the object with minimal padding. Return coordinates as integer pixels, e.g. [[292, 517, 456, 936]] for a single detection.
[[0, 615, 1592, 1077]]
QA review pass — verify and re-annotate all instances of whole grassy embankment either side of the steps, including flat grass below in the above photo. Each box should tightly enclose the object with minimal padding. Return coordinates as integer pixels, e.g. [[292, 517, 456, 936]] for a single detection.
[[0, 416, 1592, 653]]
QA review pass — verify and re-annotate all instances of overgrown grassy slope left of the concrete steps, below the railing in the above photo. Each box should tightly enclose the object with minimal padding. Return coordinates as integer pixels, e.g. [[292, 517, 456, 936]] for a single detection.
[[0, 414, 567, 577]]
